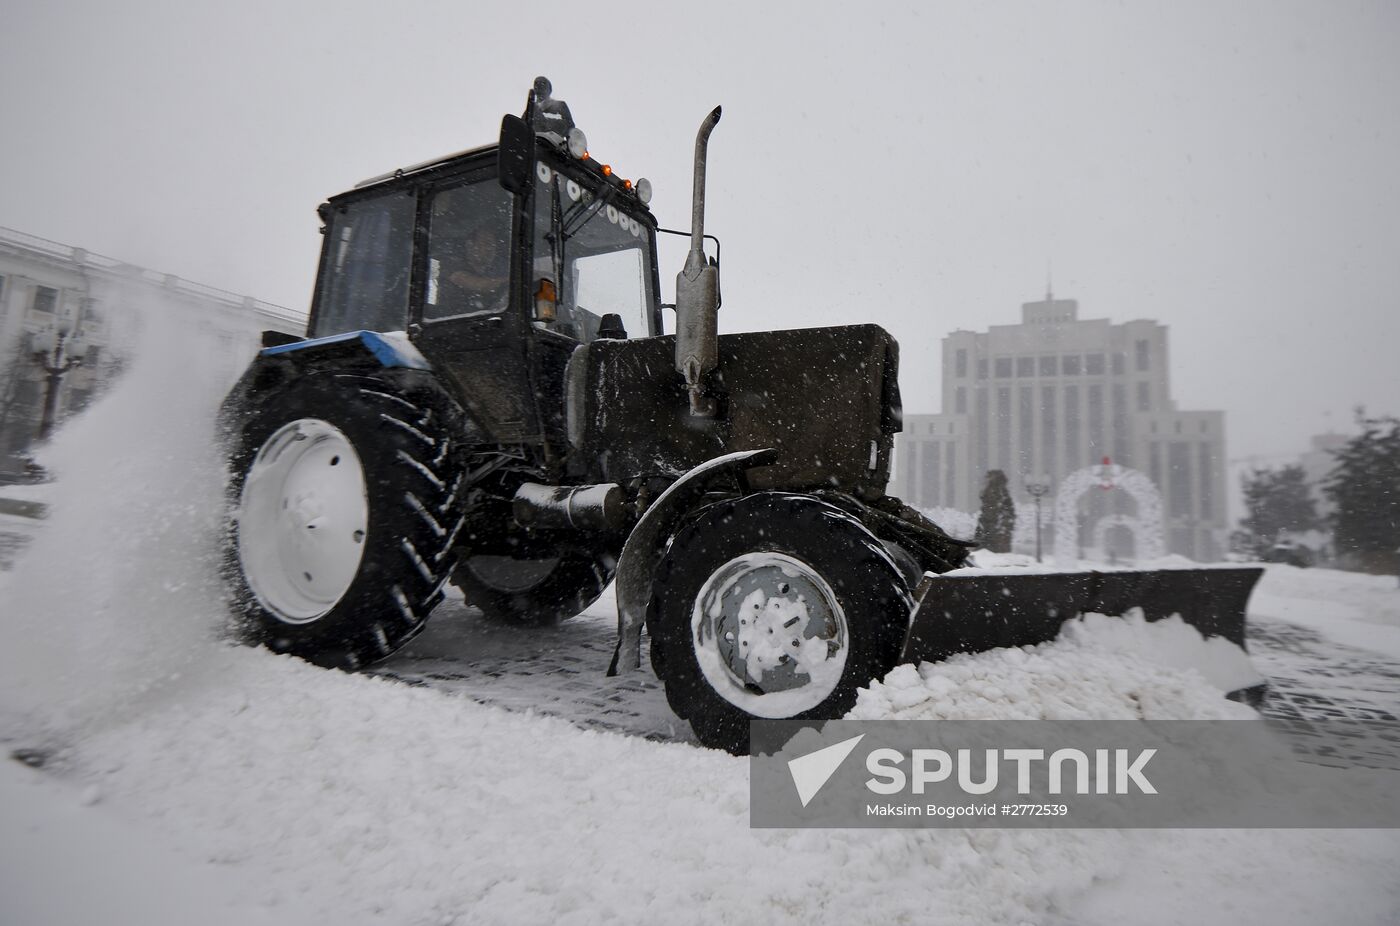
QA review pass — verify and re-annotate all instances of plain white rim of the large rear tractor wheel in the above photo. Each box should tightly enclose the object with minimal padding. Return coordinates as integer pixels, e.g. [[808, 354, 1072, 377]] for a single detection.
[[238, 417, 370, 623]]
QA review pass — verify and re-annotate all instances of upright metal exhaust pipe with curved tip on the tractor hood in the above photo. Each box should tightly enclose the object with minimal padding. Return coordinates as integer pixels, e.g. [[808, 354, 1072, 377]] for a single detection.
[[676, 106, 720, 417]]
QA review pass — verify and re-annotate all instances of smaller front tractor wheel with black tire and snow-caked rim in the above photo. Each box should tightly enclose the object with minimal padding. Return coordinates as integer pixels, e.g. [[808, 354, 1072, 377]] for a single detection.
[[647, 492, 911, 754]]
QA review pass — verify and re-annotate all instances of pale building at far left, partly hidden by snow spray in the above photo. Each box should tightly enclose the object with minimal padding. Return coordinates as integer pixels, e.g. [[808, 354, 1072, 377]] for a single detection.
[[0, 222, 305, 474]]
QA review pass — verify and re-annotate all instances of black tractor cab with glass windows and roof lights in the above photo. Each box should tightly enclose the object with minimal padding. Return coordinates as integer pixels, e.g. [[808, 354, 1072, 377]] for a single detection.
[[309, 78, 661, 458]]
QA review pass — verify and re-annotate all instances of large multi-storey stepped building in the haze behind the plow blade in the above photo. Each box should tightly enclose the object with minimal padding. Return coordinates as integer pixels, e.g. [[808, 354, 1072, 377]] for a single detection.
[[890, 293, 1228, 560]]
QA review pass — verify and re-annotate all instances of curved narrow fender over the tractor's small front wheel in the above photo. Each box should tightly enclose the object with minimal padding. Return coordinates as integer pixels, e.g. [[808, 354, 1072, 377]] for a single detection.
[[608, 448, 776, 675]]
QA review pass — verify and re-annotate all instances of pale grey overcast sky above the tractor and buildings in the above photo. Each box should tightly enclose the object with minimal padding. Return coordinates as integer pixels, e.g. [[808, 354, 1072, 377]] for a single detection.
[[0, 0, 1400, 476]]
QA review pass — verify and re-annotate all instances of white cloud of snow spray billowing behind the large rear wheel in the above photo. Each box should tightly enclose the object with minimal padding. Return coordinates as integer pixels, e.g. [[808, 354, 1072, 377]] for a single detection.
[[0, 296, 252, 745]]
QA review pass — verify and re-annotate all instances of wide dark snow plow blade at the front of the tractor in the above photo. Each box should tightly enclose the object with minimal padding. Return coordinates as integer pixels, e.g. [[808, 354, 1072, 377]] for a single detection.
[[900, 567, 1264, 664]]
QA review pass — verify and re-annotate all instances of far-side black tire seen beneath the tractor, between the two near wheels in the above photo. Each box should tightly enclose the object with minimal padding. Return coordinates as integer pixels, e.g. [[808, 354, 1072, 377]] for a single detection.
[[452, 537, 617, 626]]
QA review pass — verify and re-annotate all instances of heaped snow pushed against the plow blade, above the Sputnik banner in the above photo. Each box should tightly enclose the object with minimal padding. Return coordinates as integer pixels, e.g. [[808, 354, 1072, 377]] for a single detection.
[[847, 615, 1257, 720]]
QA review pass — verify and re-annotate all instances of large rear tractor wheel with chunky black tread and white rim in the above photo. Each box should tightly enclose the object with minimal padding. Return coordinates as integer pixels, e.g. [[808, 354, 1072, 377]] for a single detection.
[[224, 373, 465, 670]]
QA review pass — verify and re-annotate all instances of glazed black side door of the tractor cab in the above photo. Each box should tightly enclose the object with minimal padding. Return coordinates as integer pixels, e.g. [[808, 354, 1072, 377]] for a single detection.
[[416, 170, 539, 443]]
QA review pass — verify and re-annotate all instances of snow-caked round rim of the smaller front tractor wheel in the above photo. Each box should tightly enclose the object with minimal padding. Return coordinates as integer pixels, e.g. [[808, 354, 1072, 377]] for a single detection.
[[690, 552, 850, 717]]
